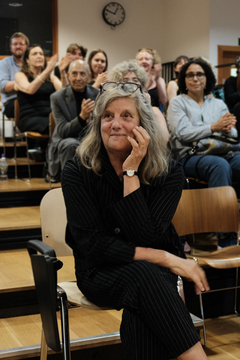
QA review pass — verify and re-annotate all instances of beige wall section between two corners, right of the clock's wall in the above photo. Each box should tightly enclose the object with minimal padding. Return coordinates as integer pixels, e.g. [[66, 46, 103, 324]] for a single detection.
[[162, 0, 210, 62]]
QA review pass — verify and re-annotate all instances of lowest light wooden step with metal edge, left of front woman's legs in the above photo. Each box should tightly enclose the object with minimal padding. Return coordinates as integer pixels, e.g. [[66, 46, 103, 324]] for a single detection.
[[0, 308, 121, 359]]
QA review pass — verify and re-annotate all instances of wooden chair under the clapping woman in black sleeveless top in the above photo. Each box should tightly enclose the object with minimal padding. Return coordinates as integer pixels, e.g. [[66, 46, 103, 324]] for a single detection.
[[14, 100, 49, 180]]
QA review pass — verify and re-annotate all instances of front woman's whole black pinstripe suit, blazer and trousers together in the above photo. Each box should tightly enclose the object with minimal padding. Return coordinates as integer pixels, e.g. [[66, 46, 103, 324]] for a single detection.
[[62, 154, 199, 360]]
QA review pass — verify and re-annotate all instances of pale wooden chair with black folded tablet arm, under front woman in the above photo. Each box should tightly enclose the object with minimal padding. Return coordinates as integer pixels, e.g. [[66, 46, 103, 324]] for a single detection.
[[27, 188, 115, 360]]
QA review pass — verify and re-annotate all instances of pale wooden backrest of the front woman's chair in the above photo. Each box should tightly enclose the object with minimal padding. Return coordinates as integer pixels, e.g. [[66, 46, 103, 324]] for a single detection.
[[40, 188, 72, 256]]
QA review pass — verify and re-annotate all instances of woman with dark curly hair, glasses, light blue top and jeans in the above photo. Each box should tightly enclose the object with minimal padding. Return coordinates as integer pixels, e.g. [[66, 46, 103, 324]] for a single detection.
[[167, 60, 240, 246]]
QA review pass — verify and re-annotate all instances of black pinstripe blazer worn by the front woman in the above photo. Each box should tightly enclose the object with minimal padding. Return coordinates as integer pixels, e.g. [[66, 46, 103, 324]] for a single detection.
[[62, 153, 185, 271]]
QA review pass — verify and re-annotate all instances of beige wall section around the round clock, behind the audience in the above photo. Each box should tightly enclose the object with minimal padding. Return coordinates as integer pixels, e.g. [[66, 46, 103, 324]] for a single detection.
[[58, 0, 163, 69]]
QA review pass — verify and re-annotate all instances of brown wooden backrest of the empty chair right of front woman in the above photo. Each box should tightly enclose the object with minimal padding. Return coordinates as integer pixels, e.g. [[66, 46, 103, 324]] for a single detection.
[[172, 186, 239, 236]]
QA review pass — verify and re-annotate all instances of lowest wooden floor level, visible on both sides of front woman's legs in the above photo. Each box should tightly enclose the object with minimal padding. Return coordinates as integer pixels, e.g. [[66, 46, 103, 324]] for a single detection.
[[0, 308, 240, 360]]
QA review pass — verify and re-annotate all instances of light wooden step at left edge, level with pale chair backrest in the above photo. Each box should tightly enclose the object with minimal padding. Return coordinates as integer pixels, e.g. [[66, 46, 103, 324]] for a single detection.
[[0, 206, 41, 231]]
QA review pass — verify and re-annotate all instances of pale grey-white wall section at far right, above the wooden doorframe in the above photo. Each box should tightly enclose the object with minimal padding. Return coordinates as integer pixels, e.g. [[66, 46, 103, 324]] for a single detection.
[[210, 0, 240, 65]]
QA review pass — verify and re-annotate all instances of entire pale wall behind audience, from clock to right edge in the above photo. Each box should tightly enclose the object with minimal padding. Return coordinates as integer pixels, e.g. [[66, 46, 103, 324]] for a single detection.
[[58, 0, 240, 79]]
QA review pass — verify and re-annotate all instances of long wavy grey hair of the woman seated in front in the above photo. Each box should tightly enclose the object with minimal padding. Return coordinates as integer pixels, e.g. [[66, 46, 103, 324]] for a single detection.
[[77, 86, 170, 184]]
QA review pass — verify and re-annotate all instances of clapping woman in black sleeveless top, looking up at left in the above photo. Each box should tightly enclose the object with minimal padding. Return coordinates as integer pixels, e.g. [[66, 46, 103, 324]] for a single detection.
[[15, 44, 62, 134]]
